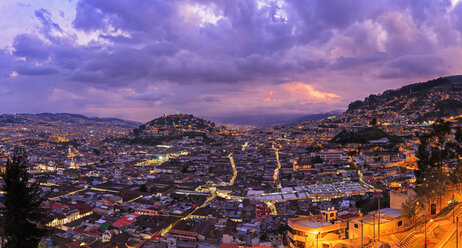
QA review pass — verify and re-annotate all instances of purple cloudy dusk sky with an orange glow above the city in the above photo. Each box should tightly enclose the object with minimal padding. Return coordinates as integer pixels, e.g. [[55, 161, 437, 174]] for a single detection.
[[0, 0, 462, 121]]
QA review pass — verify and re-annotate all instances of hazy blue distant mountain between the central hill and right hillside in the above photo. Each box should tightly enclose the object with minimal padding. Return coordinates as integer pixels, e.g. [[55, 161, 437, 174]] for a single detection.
[[211, 111, 340, 126]]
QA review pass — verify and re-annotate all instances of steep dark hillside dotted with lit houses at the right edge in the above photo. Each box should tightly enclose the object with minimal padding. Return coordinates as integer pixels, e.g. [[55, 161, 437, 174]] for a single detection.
[[342, 75, 462, 124]]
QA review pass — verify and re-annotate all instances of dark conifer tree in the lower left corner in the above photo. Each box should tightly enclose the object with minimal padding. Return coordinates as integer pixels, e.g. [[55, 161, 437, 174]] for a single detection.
[[1, 149, 50, 248]]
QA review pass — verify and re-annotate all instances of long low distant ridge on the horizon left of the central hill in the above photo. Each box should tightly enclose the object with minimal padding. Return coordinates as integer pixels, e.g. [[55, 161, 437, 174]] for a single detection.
[[0, 113, 140, 129]]
